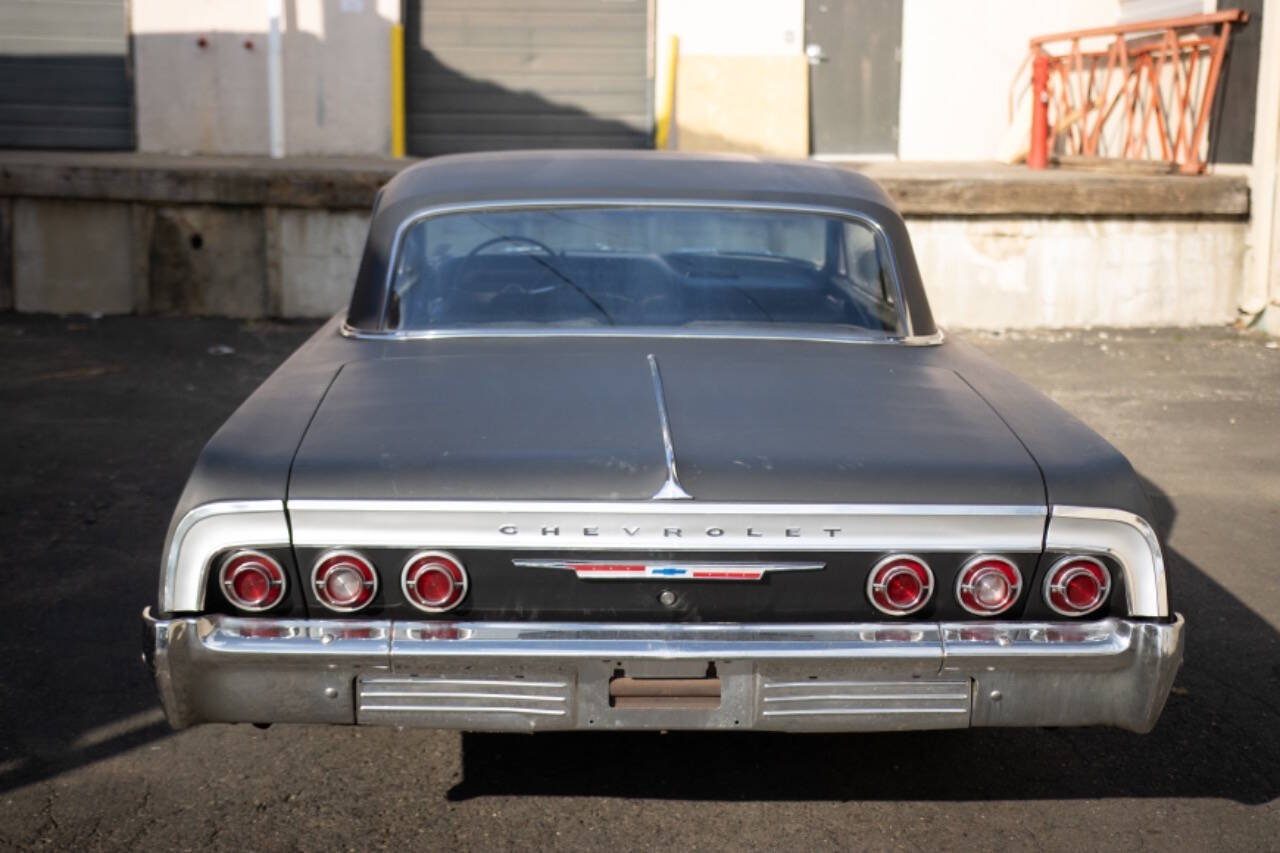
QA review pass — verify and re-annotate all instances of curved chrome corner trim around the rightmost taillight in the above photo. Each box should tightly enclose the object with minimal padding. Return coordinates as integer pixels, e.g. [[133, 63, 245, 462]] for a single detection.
[[1044, 506, 1169, 619]]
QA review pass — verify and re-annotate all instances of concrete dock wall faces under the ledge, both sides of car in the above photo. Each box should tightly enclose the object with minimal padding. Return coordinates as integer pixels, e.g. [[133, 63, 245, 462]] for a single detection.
[[0, 199, 1248, 329]]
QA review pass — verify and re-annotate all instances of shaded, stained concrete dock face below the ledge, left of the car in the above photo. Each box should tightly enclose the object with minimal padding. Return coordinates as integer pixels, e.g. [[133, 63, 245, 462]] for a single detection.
[[0, 199, 369, 319]]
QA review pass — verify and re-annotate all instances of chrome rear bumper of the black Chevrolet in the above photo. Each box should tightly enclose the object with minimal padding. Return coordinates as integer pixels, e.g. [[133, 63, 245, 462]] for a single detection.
[[142, 608, 1183, 731]]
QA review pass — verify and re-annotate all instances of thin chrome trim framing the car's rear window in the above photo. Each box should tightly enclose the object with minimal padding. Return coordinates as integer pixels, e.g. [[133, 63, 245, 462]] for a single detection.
[[342, 197, 942, 346]]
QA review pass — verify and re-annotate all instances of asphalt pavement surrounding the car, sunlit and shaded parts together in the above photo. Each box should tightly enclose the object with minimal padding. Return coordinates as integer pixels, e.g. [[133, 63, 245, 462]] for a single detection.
[[0, 315, 1280, 850]]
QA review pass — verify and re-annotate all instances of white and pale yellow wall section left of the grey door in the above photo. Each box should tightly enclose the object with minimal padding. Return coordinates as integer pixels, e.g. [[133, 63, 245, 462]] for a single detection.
[[657, 0, 809, 156]]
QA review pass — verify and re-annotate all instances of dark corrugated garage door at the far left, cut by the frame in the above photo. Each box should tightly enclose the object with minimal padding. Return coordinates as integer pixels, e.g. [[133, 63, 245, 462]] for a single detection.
[[0, 0, 133, 149]]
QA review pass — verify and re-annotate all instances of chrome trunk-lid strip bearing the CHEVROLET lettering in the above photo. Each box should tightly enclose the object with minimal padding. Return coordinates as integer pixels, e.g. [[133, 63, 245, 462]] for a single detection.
[[288, 500, 1047, 552]]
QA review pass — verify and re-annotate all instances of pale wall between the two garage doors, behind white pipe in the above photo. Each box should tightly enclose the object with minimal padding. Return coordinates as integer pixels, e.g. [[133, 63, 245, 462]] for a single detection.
[[131, 0, 399, 155]]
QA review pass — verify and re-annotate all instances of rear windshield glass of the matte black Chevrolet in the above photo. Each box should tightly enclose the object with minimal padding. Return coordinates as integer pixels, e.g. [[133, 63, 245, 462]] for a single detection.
[[388, 206, 901, 334]]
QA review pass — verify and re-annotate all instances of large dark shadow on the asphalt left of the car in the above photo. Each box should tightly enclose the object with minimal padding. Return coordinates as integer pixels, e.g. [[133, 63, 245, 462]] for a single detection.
[[0, 315, 325, 792]]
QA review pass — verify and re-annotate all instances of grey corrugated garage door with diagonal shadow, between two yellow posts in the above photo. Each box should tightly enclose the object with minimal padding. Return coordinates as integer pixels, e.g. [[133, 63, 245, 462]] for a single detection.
[[404, 0, 652, 156]]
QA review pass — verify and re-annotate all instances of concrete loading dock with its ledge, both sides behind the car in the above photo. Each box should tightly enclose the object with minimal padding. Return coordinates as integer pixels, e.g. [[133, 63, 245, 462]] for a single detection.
[[0, 152, 1249, 328]]
